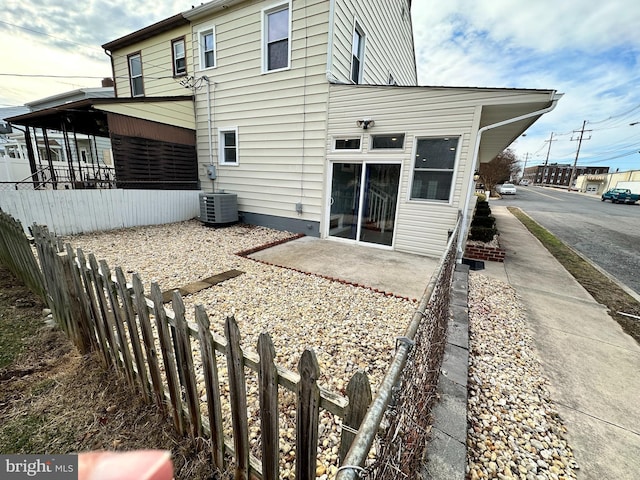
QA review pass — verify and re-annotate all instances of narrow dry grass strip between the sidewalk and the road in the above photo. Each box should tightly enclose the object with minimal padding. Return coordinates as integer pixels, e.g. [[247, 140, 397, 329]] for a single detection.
[[509, 207, 640, 343]]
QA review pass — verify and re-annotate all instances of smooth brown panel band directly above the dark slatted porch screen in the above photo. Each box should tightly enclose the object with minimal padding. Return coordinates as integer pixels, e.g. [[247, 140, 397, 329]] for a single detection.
[[107, 113, 196, 146]]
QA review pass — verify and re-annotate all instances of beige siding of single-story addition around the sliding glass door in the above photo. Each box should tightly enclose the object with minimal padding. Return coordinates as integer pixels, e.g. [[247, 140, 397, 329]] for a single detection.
[[327, 85, 482, 257]]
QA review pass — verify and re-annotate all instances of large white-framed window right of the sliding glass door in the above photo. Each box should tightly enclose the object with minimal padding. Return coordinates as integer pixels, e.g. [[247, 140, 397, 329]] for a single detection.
[[411, 137, 460, 202]]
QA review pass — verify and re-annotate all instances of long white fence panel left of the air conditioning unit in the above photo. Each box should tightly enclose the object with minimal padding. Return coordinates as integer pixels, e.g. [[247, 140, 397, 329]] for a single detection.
[[0, 189, 201, 235]]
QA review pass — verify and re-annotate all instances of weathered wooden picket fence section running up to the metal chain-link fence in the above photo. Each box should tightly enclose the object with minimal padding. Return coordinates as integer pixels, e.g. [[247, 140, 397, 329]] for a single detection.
[[25, 225, 371, 480]]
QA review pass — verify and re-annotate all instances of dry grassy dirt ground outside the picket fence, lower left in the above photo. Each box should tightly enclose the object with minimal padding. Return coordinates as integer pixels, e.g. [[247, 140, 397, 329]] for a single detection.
[[0, 266, 226, 479]]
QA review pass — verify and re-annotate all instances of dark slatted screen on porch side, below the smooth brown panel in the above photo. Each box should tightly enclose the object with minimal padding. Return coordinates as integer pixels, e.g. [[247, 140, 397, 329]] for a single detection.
[[111, 132, 198, 190]]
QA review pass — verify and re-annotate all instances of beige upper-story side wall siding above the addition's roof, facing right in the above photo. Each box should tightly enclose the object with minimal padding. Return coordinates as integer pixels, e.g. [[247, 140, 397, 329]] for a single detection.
[[331, 0, 417, 85]]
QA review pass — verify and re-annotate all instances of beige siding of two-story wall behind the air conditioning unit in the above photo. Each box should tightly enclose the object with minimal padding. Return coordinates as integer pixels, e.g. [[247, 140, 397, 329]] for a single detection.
[[192, 0, 328, 221]]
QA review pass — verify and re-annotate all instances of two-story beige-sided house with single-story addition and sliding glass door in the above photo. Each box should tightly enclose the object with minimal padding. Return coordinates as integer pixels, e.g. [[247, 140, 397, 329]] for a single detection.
[[8, 0, 559, 256]]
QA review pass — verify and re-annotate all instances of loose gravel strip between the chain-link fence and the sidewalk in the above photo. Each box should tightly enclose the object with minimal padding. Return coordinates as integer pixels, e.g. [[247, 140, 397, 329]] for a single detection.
[[467, 272, 578, 480]]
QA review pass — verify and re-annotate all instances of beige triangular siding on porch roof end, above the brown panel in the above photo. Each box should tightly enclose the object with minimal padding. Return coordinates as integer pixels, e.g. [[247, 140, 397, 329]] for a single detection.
[[95, 100, 195, 130]]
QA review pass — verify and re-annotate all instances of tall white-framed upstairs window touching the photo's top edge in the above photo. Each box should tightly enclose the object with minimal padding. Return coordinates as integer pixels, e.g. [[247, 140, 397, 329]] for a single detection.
[[262, 2, 291, 72]]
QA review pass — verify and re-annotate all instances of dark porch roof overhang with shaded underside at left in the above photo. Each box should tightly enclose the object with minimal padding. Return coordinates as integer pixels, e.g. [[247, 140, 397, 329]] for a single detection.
[[6, 96, 193, 137]]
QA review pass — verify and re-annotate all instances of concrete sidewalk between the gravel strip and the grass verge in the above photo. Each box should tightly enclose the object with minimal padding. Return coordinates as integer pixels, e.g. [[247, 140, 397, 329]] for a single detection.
[[479, 205, 640, 480]]
